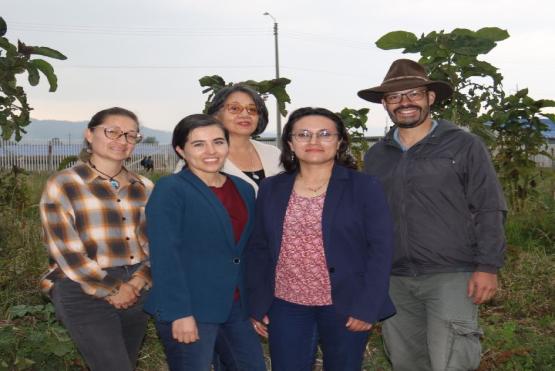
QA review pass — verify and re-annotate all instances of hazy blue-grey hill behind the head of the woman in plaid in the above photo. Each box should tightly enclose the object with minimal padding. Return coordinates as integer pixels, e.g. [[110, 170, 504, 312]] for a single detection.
[[22, 119, 172, 144]]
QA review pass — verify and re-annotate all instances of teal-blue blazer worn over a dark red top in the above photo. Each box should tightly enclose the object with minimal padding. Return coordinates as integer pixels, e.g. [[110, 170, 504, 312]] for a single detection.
[[144, 169, 254, 323]]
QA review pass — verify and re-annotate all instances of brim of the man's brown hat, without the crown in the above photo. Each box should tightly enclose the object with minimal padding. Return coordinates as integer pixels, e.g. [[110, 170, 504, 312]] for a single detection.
[[358, 79, 453, 103]]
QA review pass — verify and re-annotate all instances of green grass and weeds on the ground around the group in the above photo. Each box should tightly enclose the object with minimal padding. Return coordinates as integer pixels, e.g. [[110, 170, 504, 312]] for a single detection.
[[0, 173, 555, 371]]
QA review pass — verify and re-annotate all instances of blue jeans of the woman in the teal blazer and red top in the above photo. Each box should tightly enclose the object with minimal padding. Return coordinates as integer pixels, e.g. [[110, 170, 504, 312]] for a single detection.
[[156, 302, 266, 371]]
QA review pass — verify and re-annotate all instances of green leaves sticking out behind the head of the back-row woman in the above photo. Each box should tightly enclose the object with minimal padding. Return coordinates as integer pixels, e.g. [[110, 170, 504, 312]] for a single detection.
[[199, 75, 291, 116]]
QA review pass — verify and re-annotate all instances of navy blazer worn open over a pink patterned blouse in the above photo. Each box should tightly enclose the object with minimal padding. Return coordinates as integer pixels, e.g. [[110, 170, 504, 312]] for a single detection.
[[246, 165, 395, 322]]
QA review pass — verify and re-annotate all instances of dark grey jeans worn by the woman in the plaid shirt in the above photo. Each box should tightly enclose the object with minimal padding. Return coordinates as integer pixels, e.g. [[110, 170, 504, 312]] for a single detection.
[[51, 266, 148, 371]]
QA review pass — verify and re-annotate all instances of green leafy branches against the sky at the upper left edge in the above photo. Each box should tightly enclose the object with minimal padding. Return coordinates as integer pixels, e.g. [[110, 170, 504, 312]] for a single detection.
[[0, 17, 66, 141]]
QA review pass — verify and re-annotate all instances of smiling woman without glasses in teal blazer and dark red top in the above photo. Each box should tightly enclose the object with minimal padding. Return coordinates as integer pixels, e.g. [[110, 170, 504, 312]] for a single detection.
[[145, 115, 266, 371]]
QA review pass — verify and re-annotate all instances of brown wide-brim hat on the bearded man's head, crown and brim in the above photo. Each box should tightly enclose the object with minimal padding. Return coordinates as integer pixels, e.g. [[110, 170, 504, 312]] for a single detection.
[[358, 59, 453, 103]]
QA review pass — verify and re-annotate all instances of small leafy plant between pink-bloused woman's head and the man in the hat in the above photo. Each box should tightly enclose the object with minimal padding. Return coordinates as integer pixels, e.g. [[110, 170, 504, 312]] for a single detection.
[[337, 108, 370, 168]]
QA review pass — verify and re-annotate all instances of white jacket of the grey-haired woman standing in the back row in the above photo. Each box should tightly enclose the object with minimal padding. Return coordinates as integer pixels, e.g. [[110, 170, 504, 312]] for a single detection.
[[174, 139, 283, 192]]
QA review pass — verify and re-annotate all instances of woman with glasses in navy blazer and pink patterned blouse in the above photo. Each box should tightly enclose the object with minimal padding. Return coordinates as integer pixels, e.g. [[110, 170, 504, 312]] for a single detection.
[[246, 108, 395, 371]]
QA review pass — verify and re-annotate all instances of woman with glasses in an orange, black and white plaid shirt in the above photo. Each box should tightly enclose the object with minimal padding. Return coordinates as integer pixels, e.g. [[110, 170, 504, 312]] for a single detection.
[[40, 107, 153, 371]]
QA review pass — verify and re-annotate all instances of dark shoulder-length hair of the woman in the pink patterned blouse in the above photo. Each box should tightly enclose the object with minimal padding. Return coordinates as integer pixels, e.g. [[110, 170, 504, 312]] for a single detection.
[[280, 107, 357, 172]]
